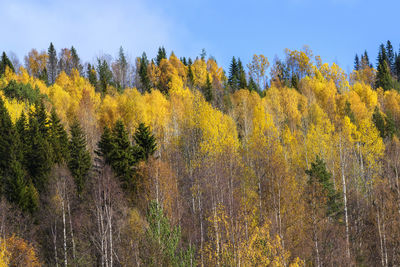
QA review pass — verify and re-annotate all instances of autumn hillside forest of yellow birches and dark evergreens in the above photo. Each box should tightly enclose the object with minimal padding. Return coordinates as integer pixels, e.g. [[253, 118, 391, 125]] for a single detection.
[[0, 41, 400, 267]]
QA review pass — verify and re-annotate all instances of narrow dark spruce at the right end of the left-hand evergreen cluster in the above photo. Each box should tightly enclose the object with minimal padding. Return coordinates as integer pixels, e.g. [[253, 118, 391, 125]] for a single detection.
[[68, 119, 92, 195]]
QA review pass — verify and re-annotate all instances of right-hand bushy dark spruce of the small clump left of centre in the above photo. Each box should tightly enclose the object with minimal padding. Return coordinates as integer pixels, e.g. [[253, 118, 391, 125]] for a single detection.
[[133, 123, 157, 161]]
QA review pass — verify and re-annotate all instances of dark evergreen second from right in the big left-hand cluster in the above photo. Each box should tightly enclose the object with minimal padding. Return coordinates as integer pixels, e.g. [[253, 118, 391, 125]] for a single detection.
[[49, 109, 69, 164]]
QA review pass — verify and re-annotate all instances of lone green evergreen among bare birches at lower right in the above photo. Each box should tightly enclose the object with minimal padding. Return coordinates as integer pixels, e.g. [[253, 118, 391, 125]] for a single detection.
[[306, 156, 343, 219]]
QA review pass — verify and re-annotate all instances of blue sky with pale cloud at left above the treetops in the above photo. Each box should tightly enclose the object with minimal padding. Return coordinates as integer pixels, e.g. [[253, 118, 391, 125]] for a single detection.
[[0, 0, 400, 72]]
